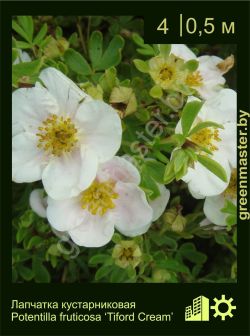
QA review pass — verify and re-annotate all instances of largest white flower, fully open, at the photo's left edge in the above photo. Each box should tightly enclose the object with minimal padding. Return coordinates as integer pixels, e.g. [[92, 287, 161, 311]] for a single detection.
[[12, 68, 122, 199]]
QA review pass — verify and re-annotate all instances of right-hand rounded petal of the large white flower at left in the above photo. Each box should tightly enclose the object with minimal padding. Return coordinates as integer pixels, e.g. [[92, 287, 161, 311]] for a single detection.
[[76, 101, 122, 162]]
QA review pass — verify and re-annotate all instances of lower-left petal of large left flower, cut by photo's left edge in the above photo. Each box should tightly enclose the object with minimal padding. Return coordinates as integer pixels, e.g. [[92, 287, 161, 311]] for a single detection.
[[12, 133, 44, 183]]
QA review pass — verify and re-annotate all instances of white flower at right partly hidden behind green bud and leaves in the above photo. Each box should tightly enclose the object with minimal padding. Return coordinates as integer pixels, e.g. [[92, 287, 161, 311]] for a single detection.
[[175, 89, 237, 198]]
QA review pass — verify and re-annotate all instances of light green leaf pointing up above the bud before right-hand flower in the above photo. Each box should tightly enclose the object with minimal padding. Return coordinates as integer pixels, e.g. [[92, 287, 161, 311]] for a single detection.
[[181, 100, 203, 136]]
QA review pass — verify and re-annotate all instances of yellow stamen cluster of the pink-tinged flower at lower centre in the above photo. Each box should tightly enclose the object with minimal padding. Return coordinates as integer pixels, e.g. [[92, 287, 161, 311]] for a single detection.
[[81, 180, 119, 216]]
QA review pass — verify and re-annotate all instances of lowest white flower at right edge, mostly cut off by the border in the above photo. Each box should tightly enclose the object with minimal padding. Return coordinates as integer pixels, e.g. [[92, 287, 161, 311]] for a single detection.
[[203, 169, 237, 226]]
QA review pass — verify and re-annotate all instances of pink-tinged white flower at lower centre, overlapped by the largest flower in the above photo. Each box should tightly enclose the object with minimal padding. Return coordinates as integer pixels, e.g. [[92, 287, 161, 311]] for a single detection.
[[47, 156, 170, 247]]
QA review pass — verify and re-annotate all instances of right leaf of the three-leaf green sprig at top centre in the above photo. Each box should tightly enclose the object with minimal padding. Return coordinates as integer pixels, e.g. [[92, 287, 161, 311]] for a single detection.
[[96, 35, 124, 70]]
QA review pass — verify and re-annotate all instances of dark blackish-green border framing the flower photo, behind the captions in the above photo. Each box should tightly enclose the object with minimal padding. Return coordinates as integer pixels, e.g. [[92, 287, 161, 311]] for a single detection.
[[0, 1, 250, 335]]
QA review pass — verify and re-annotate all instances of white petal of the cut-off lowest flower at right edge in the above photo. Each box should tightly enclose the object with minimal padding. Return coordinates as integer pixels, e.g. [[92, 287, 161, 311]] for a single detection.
[[203, 195, 228, 225]]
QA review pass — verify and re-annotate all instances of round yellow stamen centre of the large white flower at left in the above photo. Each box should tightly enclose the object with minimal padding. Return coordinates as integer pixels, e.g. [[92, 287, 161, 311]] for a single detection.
[[36, 114, 78, 156]]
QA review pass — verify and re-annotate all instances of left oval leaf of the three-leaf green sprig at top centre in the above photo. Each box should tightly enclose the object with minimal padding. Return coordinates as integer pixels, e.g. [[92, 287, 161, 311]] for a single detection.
[[64, 48, 92, 76]]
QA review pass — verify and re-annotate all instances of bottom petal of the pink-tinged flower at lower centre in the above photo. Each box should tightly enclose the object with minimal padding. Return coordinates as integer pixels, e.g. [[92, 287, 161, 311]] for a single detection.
[[69, 216, 114, 247]]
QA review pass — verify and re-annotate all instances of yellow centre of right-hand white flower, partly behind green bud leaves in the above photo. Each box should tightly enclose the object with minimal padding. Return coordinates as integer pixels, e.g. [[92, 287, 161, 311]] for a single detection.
[[190, 127, 221, 152]]
